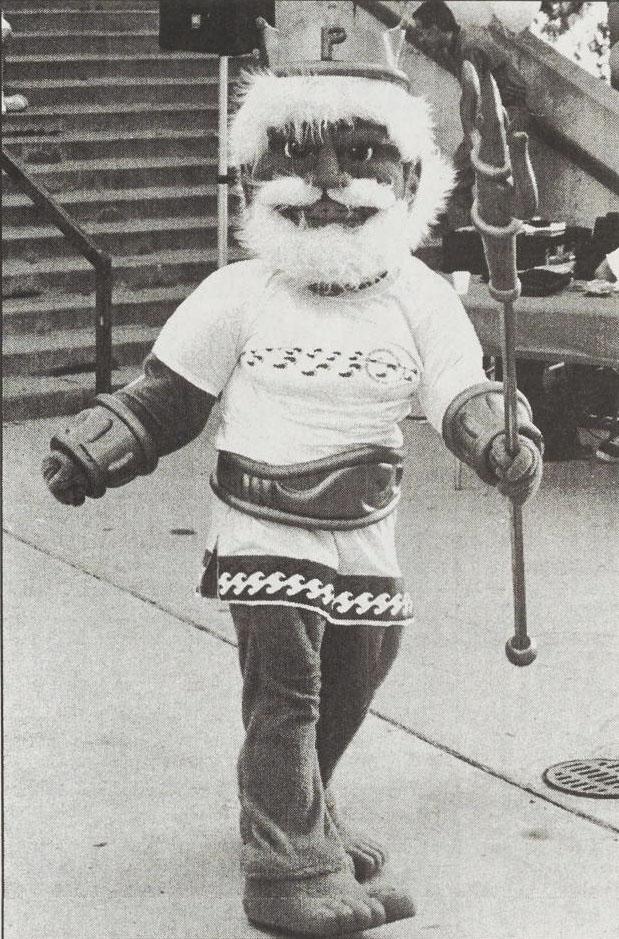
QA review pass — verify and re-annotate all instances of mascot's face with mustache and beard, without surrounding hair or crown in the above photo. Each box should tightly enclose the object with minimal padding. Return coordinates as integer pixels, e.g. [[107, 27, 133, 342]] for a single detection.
[[241, 120, 422, 286]]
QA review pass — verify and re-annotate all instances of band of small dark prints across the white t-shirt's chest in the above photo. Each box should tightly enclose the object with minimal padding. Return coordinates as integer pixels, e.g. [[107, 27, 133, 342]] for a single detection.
[[240, 346, 418, 384]]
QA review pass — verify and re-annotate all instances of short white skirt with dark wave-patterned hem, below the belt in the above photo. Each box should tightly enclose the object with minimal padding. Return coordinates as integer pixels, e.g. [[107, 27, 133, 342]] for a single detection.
[[198, 498, 413, 626]]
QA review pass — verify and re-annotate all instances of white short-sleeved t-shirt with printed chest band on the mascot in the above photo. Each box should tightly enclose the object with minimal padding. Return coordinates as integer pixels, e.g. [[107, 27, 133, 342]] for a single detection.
[[153, 257, 485, 464]]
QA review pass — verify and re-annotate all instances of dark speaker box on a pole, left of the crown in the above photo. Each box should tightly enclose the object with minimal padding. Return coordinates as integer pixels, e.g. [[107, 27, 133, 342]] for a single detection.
[[159, 0, 275, 56]]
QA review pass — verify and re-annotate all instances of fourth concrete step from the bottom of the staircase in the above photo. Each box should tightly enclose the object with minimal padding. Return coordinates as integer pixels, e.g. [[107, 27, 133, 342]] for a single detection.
[[2, 247, 243, 298]]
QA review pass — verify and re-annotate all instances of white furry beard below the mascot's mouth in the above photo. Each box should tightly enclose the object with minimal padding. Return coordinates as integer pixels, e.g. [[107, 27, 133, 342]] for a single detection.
[[237, 193, 410, 286]]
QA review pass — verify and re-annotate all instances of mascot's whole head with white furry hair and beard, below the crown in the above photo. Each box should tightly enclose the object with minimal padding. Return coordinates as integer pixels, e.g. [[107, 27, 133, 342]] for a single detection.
[[231, 73, 452, 288]]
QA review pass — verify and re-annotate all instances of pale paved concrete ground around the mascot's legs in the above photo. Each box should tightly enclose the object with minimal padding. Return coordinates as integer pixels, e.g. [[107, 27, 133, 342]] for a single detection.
[[4, 421, 619, 939]]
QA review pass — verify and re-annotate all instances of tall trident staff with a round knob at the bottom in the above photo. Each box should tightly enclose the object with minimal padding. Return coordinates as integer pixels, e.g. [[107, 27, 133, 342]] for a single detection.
[[460, 62, 538, 666]]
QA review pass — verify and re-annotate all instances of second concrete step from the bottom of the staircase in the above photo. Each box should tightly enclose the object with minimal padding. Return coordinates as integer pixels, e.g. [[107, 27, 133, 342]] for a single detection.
[[2, 324, 159, 376]]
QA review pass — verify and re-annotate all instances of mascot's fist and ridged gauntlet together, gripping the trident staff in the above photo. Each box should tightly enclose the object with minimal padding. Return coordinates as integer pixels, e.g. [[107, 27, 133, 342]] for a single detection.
[[443, 382, 544, 504]]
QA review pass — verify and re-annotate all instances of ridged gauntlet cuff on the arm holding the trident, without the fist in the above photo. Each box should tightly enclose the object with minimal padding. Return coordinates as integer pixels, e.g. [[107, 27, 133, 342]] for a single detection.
[[443, 381, 543, 485]]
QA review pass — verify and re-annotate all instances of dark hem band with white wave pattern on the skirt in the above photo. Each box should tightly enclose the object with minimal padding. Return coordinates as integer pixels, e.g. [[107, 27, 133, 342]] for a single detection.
[[201, 555, 413, 623]]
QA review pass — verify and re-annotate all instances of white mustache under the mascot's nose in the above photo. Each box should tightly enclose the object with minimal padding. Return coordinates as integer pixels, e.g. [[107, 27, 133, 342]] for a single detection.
[[256, 176, 397, 209]]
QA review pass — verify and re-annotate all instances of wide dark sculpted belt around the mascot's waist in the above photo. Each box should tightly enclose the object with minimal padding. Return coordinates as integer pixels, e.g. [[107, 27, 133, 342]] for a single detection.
[[211, 447, 404, 531]]
